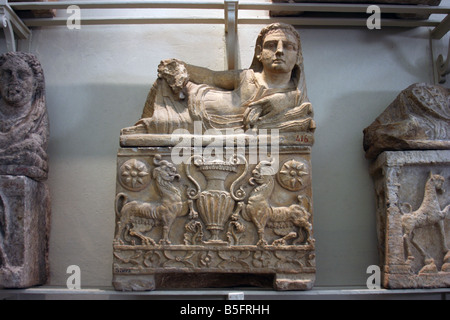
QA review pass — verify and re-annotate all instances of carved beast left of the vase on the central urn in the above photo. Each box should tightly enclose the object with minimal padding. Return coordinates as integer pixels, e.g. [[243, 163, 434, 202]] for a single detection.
[[115, 155, 188, 245]]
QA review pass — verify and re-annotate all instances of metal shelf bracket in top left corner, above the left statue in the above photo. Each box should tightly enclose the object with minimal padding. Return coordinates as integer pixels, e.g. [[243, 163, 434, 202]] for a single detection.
[[0, 0, 31, 51]]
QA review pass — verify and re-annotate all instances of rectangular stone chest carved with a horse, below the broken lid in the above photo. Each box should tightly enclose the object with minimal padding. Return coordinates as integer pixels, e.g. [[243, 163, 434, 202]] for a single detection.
[[371, 150, 450, 289]]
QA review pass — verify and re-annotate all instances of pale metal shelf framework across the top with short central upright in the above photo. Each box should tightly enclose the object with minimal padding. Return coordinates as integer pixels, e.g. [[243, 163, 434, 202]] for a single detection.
[[0, 0, 450, 69]]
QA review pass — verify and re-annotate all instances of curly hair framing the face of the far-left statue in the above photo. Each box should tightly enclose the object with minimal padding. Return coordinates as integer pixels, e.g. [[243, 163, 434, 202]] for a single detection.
[[0, 52, 45, 101]]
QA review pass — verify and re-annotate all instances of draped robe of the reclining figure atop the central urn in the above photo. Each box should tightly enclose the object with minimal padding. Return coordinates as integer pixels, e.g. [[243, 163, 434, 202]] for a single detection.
[[137, 69, 313, 134]]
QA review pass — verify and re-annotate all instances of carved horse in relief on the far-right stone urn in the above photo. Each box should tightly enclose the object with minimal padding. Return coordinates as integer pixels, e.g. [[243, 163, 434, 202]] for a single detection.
[[402, 173, 450, 273]]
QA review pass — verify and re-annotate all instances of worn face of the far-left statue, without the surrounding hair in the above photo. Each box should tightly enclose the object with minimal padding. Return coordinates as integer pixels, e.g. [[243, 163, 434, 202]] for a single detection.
[[0, 59, 34, 107]]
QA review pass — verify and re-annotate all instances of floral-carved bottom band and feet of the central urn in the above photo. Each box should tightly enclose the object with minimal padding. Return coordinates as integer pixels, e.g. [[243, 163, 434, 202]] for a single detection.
[[113, 245, 315, 291]]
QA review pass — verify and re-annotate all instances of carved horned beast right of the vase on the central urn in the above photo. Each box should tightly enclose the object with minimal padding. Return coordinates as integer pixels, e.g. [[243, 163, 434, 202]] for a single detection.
[[242, 161, 314, 246]]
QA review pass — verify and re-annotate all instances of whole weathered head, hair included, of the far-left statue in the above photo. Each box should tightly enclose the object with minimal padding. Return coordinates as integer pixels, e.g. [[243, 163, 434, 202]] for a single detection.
[[0, 52, 44, 111]]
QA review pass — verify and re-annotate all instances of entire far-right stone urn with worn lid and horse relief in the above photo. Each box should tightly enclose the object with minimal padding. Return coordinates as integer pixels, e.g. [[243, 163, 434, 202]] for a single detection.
[[364, 84, 450, 289]]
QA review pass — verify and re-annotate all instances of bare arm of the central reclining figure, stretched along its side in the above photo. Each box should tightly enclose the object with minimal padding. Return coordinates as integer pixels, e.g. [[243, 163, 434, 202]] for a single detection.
[[184, 63, 240, 90]]
